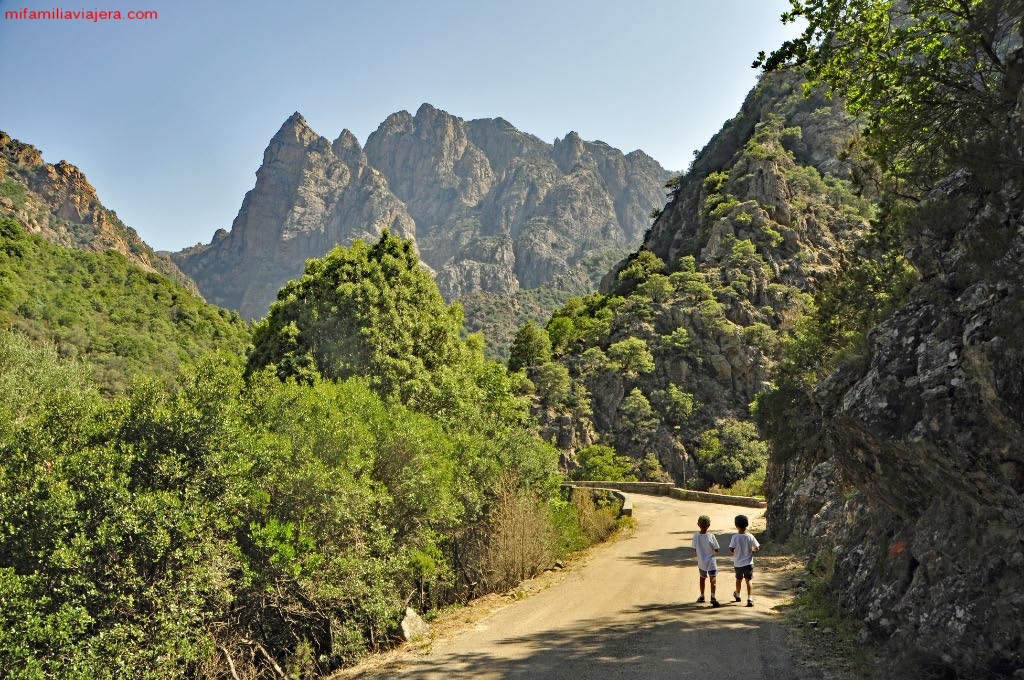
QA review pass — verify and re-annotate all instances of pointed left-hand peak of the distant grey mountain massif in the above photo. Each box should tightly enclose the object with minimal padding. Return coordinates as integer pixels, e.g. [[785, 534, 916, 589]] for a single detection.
[[173, 113, 416, 318]]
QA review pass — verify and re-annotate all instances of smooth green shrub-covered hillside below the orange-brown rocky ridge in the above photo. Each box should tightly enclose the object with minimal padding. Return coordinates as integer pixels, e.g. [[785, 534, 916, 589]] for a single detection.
[[0, 218, 249, 392]]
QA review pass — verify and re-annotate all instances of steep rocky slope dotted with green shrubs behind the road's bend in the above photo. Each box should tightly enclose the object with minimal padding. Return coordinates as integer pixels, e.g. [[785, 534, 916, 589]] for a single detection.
[[548, 74, 872, 485]]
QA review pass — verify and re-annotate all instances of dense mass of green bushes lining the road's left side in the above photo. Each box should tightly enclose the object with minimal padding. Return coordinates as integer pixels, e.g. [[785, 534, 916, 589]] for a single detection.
[[0, 236, 596, 678]]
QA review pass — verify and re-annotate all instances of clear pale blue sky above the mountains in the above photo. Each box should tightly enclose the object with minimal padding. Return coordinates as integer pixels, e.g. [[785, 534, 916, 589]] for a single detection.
[[0, 0, 793, 250]]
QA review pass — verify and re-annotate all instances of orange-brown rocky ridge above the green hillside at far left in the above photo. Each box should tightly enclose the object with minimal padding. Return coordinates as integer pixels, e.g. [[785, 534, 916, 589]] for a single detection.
[[0, 132, 196, 292]]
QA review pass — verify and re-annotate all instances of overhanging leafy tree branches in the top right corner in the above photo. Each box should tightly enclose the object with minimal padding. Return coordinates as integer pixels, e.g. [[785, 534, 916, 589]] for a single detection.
[[754, 0, 1024, 186]]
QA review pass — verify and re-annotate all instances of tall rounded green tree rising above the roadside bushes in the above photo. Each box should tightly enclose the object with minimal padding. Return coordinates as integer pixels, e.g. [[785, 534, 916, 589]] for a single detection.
[[248, 231, 472, 411]]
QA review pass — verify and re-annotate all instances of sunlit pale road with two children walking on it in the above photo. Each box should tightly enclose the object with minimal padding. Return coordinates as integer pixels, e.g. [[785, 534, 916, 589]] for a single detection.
[[339, 495, 819, 680]]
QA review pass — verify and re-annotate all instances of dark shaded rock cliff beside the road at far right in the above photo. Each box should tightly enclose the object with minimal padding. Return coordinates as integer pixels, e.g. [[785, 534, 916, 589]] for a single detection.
[[769, 90, 1024, 679]]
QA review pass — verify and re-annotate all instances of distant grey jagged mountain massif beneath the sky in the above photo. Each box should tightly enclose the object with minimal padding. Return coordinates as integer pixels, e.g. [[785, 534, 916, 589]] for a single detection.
[[174, 104, 668, 317]]
